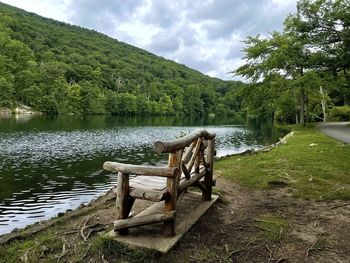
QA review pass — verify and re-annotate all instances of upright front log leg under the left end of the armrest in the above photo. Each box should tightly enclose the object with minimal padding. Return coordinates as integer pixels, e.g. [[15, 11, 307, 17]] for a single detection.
[[116, 172, 130, 235]]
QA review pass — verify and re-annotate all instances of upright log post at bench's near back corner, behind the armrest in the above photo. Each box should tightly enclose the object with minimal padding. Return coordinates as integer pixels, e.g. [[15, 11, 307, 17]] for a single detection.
[[163, 152, 181, 236]]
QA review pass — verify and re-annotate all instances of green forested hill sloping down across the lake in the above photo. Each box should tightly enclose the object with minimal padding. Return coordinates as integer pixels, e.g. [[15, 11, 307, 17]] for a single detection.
[[0, 3, 242, 114]]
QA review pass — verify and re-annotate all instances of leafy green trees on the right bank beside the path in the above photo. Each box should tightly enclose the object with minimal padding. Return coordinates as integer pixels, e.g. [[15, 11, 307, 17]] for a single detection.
[[234, 0, 350, 125]]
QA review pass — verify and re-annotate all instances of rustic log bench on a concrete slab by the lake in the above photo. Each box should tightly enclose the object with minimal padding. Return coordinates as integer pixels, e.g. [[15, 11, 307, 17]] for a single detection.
[[103, 130, 215, 236]]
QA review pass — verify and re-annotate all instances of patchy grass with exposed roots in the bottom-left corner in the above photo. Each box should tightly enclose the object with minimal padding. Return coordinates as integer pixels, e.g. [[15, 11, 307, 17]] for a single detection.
[[0, 226, 158, 263]]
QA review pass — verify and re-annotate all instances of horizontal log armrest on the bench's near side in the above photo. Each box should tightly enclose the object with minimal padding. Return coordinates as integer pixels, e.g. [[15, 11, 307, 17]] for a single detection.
[[103, 162, 178, 177]]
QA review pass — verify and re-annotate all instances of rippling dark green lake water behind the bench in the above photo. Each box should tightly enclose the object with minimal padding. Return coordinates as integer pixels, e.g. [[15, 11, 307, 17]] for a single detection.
[[0, 115, 281, 234]]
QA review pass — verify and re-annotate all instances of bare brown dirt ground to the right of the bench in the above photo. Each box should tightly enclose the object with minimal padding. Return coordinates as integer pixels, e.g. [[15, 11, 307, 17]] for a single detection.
[[175, 177, 350, 263]]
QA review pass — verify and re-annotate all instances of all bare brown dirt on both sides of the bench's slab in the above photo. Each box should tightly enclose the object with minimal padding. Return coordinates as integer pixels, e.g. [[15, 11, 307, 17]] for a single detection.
[[1, 176, 350, 263]]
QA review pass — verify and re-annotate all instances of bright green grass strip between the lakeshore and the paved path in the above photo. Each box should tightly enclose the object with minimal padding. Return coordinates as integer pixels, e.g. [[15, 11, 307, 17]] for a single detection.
[[215, 126, 350, 200]]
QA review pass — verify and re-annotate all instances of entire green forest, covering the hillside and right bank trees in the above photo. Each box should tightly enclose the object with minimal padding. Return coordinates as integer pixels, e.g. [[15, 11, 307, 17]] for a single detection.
[[0, 0, 350, 122]]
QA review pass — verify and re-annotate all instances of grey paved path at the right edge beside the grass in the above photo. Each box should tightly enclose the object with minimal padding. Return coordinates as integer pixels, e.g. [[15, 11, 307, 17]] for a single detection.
[[318, 122, 350, 144]]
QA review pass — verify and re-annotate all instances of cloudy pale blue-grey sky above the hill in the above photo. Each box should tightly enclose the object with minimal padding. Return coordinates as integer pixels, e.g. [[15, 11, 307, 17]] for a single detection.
[[0, 0, 297, 80]]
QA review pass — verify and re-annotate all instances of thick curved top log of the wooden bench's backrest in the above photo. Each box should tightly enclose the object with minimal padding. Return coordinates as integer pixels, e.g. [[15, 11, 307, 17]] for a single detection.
[[153, 130, 215, 153]]
